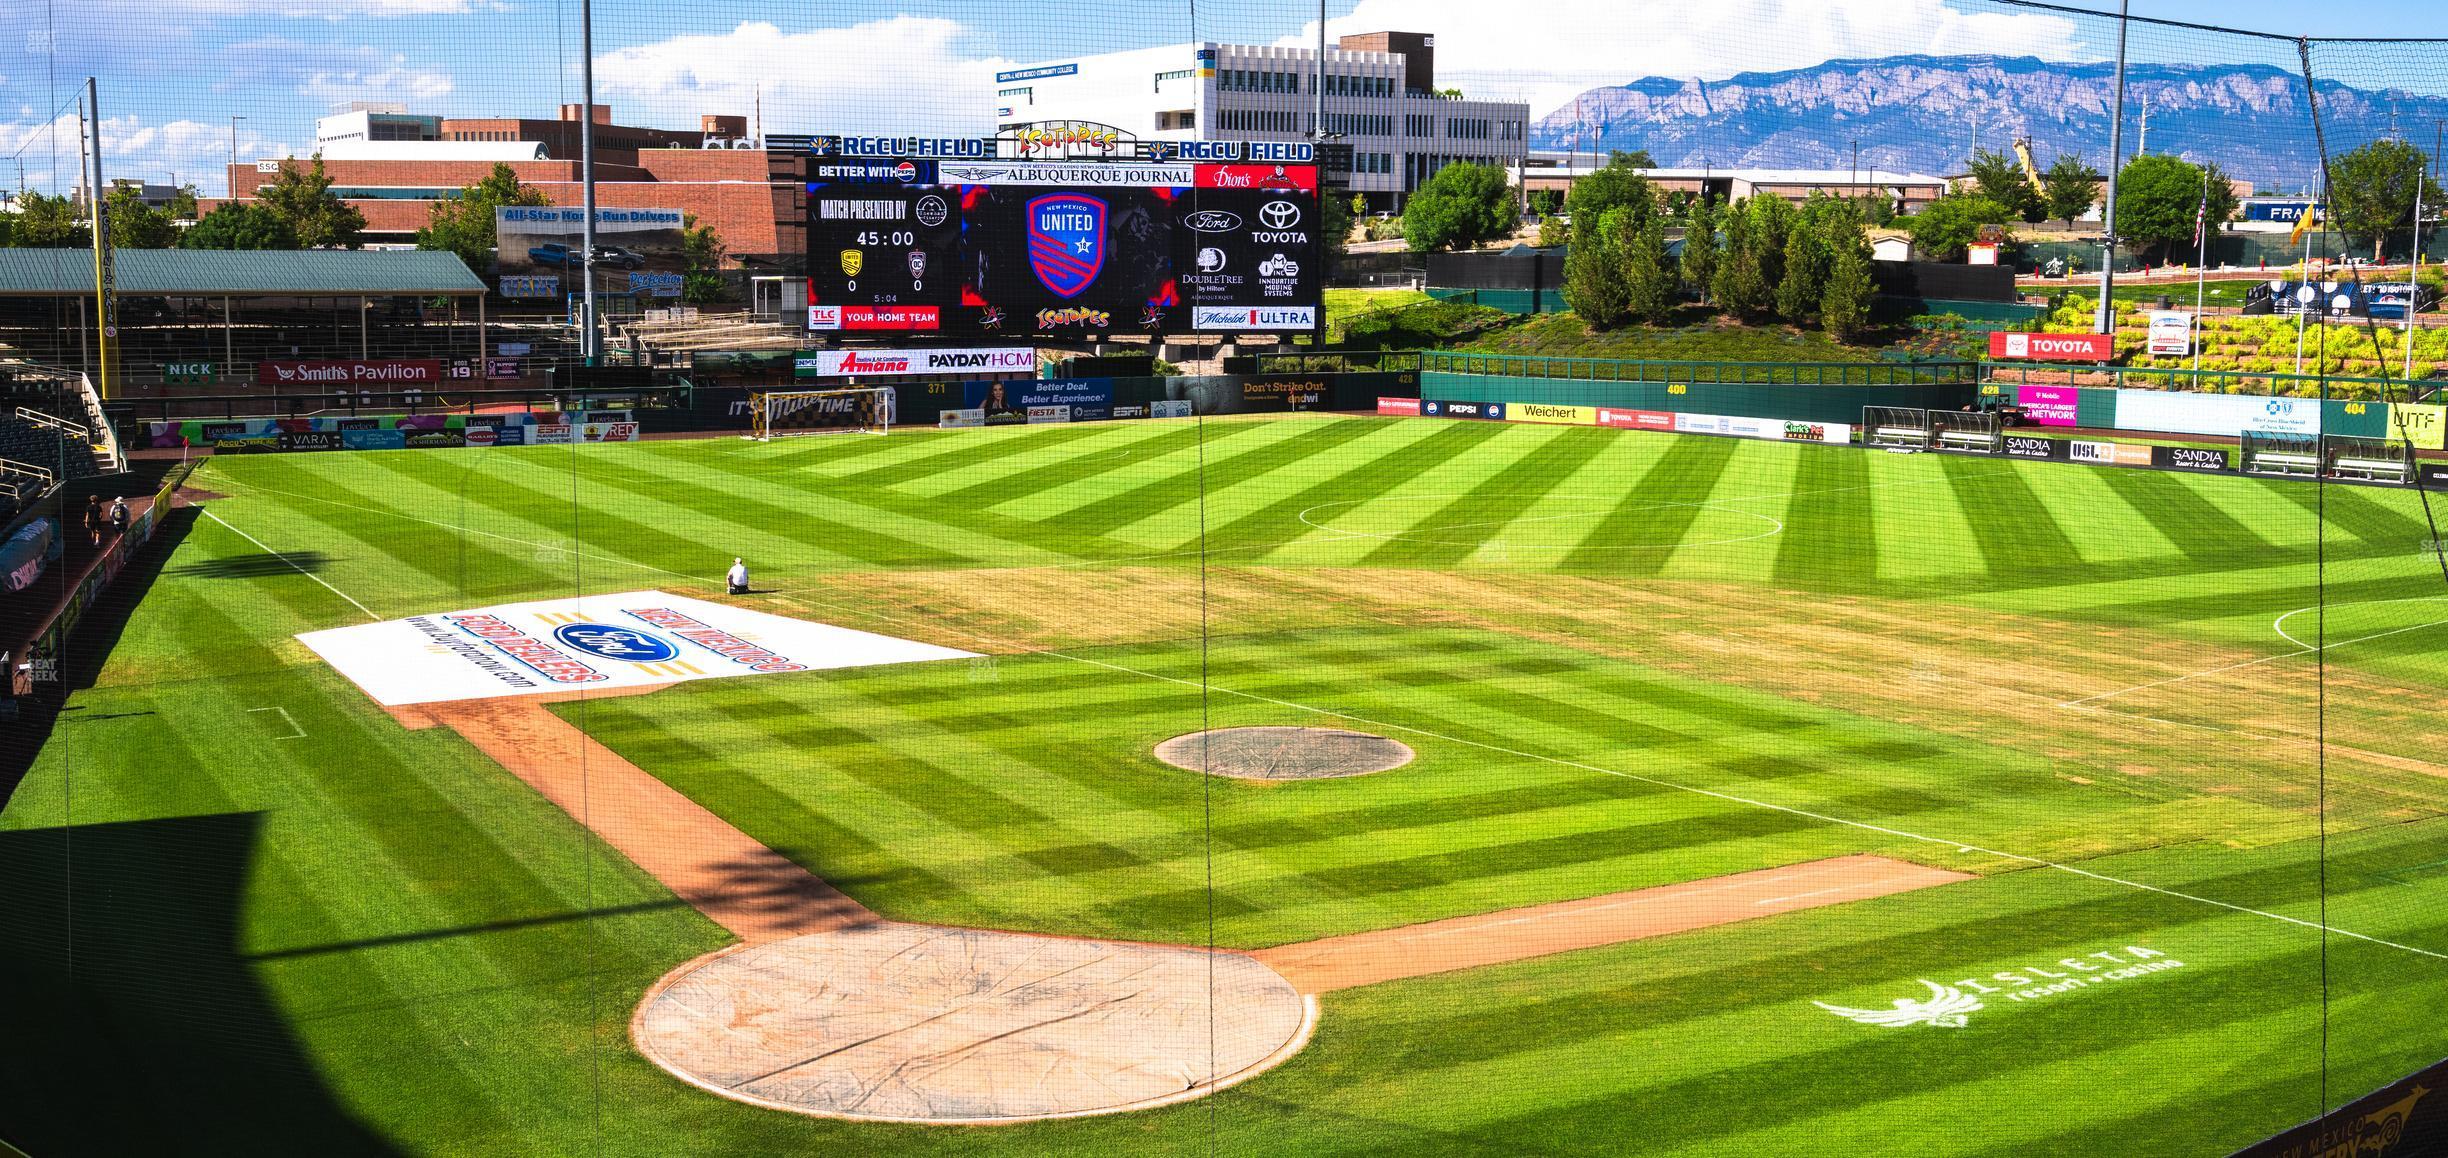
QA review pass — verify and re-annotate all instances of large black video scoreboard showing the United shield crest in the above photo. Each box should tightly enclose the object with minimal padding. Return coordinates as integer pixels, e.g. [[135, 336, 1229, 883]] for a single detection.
[[808, 159, 1324, 335]]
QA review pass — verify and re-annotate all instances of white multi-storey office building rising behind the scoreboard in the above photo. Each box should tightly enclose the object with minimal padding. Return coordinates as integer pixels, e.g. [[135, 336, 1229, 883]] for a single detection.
[[994, 32, 1530, 208]]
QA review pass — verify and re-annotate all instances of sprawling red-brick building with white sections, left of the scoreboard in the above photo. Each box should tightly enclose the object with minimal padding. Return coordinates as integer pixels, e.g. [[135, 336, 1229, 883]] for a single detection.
[[198, 105, 808, 269]]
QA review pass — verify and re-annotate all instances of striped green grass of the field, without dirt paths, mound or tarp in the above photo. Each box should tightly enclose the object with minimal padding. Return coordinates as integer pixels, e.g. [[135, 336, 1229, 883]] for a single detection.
[[0, 416, 2448, 1158]]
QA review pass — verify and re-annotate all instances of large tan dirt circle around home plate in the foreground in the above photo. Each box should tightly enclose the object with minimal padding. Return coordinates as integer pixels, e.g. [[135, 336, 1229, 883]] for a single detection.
[[629, 921, 1317, 1126]]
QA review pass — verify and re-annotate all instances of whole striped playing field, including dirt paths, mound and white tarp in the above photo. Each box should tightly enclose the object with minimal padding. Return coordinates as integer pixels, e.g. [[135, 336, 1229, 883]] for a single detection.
[[0, 416, 2448, 1156]]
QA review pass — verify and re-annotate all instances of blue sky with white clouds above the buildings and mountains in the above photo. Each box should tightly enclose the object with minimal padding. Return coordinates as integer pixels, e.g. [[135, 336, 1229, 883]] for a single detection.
[[0, 0, 2448, 191]]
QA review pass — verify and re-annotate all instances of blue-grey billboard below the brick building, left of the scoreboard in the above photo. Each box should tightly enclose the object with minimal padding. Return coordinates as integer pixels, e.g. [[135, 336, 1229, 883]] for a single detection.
[[492, 206, 688, 299]]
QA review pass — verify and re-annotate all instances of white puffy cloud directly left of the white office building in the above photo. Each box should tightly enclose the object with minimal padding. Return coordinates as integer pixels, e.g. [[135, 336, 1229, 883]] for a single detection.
[[595, 15, 1009, 135]]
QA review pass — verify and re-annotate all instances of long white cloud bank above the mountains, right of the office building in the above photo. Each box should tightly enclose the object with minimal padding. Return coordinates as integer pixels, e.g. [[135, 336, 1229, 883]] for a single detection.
[[1278, 0, 2091, 118]]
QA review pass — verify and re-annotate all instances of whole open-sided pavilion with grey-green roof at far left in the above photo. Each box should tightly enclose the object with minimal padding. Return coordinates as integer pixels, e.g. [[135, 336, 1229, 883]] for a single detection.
[[0, 250, 487, 397]]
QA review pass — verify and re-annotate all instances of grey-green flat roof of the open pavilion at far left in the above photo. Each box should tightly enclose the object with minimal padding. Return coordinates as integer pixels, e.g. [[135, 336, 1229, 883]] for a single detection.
[[0, 250, 485, 299]]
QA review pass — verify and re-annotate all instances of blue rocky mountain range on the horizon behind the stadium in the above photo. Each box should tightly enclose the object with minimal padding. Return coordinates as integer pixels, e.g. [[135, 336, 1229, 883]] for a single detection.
[[1530, 56, 2448, 193]]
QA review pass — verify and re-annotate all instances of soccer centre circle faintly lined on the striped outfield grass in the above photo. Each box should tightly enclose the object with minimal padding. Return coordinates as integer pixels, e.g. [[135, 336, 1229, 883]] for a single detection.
[[1300, 492, 1785, 551]]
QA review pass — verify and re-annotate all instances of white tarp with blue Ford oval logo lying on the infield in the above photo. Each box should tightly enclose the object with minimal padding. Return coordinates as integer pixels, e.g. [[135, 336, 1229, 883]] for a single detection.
[[299, 590, 977, 708]]
